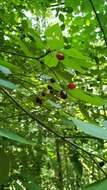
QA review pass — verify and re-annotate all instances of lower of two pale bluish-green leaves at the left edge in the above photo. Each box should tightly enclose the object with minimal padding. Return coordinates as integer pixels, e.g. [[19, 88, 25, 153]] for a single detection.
[[0, 79, 16, 89]]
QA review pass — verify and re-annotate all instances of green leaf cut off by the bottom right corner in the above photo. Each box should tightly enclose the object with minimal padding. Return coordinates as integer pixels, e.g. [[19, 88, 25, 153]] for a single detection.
[[82, 178, 107, 190]]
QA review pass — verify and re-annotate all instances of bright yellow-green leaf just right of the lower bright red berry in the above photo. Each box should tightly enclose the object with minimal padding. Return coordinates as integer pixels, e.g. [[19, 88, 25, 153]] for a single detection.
[[69, 88, 107, 106]]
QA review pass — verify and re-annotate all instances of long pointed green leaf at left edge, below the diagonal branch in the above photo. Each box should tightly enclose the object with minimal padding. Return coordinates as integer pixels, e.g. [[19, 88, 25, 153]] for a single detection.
[[0, 128, 33, 145]]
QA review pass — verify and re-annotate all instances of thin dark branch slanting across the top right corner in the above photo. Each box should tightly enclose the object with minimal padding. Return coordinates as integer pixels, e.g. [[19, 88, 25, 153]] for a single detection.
[[89, 0, 107, 46]]
